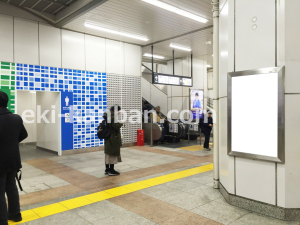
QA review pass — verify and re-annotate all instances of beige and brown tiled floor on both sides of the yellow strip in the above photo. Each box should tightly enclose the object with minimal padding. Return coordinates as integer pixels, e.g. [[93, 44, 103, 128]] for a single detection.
[[11, 143, 299, 225]]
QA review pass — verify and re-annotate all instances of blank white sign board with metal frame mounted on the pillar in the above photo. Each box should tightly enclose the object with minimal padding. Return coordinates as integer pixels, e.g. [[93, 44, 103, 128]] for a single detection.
[[228, 67, 284, 163]]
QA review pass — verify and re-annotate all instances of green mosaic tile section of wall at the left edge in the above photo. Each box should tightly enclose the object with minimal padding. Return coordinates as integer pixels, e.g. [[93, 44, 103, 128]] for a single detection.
[[0, 62, 16, 113]]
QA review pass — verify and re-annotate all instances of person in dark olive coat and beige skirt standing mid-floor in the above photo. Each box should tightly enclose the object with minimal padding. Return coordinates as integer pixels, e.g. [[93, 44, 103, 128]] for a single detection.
[[105, 105, 124, 176]]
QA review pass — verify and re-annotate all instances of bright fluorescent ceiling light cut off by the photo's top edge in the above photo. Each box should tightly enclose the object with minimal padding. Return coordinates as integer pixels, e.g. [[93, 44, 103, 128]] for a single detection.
[[142, 0, 208, 23]]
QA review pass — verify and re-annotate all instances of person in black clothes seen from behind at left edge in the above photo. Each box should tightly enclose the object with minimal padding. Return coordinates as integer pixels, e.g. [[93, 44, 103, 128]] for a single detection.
[[0, 91, 28, 225]]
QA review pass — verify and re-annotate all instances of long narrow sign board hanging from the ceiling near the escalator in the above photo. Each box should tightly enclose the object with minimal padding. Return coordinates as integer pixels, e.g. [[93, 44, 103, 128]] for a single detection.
[[152, 73, 193, 87]]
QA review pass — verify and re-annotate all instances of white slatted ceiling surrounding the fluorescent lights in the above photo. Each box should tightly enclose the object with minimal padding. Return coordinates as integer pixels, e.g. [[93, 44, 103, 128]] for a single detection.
[[64, 0, 213, 59]]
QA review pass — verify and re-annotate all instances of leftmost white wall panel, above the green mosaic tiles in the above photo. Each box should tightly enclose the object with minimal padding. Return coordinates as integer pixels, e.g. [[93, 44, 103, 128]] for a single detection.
[[0, 15, 14, 62]]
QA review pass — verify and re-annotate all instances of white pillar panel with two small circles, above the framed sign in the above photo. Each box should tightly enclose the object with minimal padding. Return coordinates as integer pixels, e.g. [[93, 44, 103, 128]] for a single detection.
[[235, 0, 275, 71]]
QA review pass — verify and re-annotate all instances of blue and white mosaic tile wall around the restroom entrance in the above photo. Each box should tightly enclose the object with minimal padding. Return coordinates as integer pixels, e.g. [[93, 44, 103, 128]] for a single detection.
[[16, 63, 107, 150]]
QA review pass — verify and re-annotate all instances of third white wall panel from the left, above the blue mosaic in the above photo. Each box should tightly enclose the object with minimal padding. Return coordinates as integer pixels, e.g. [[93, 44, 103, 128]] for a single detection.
[[39, 24, 62, 67]]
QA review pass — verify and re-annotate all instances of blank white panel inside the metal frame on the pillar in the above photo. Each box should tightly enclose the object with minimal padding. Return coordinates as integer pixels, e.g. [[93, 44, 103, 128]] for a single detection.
[[231, 73, 278, 157]]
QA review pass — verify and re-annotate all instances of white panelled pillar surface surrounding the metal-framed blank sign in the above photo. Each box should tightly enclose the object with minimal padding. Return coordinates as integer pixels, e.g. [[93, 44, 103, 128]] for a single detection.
[[219, 0, 300, 208]]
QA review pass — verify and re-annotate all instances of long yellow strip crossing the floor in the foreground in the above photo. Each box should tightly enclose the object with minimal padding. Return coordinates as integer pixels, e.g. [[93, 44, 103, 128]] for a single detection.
[[9, 164, 213, 225]]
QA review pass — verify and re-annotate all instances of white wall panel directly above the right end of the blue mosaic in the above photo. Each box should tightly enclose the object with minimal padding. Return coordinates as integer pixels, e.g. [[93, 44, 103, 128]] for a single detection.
[[85, 35, 106, 71]]
